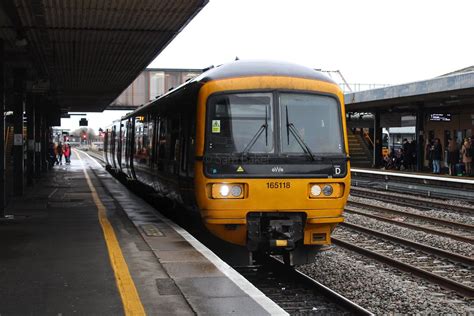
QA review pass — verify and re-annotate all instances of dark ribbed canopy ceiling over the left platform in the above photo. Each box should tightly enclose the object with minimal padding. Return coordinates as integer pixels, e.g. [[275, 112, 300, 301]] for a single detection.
[[0, 0, 207, 112]]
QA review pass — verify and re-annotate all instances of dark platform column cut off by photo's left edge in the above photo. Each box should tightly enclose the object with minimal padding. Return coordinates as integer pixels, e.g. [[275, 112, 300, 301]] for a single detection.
[[0, 38, 6, 212]]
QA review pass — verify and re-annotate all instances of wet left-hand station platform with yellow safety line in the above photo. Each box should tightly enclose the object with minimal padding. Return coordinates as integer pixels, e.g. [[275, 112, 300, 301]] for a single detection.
[[0, 151, 287, 315]]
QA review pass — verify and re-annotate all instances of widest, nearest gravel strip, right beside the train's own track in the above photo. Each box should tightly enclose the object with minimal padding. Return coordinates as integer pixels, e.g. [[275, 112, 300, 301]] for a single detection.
[[298, 246, 474, 315]]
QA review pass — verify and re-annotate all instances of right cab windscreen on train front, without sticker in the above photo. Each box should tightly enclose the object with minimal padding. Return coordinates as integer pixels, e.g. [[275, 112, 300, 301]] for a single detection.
[[279, 93, 344, 154]]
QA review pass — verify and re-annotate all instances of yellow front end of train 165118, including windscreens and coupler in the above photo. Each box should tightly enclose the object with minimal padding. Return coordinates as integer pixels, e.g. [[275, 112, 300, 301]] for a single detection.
[[195, 62, 350, 264]]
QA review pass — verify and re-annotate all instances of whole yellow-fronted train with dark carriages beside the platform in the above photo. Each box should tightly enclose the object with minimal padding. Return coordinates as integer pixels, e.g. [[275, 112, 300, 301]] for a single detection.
[[104, 61, 350, 264]]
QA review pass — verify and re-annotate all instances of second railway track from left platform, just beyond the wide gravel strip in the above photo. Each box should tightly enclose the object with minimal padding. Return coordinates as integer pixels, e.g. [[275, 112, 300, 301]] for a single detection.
[[332, 223, 474, 298]]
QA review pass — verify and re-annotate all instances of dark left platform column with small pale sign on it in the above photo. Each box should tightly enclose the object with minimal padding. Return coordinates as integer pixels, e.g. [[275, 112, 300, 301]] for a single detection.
[[13, 68, 26, 196]]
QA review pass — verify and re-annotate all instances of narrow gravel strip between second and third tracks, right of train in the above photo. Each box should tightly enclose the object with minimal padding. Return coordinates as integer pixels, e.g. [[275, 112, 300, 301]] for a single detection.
[[342, 209, 474, 257]]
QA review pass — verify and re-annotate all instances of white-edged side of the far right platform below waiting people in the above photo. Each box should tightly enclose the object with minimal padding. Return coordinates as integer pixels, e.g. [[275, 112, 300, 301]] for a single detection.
[[351, 167, 474, 202]]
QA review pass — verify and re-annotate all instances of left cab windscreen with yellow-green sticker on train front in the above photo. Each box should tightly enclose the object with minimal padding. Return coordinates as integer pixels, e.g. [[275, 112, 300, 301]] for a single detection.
[[206, 93, 274, 153]]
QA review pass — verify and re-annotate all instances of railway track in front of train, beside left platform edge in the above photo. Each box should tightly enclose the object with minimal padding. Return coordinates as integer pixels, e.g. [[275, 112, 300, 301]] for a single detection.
[[235, 257, 373, 315]]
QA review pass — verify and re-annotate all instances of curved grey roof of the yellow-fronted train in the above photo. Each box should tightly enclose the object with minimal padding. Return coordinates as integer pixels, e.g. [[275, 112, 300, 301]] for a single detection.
[[122, 60, 336, 119]]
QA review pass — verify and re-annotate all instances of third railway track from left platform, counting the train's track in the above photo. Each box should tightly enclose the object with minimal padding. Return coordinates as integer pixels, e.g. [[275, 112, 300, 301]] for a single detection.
[[345, 201, 474, 244]]
